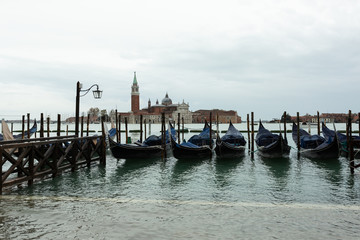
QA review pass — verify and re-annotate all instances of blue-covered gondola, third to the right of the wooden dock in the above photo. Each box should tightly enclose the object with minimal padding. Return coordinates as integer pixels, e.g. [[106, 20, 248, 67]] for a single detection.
[[215, 122, 246, 157]]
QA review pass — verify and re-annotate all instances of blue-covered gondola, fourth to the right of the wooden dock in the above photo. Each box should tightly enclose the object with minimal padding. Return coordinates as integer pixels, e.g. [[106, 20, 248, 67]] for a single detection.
[[255, 121, 290, 158]]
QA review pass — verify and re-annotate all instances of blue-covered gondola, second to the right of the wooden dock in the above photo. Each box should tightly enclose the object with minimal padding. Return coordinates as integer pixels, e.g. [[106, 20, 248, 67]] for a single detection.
[[171, 122, 212, 159]]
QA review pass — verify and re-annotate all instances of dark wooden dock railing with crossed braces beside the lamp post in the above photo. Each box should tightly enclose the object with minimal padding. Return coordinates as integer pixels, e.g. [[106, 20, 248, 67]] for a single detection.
[[0, 135, 106, 194]]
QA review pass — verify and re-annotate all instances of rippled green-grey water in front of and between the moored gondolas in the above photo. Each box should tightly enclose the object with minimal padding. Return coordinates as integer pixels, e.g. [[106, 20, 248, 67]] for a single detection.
[[0, 124, 360, 239]]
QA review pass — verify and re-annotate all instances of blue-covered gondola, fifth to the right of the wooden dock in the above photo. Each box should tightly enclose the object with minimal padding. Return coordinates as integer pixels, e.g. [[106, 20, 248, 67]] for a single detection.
[[292, 123, 339, 159]]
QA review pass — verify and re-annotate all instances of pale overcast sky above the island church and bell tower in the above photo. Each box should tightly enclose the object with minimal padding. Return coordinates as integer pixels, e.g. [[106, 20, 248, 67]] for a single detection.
[[0, 0, 360, 120]]
